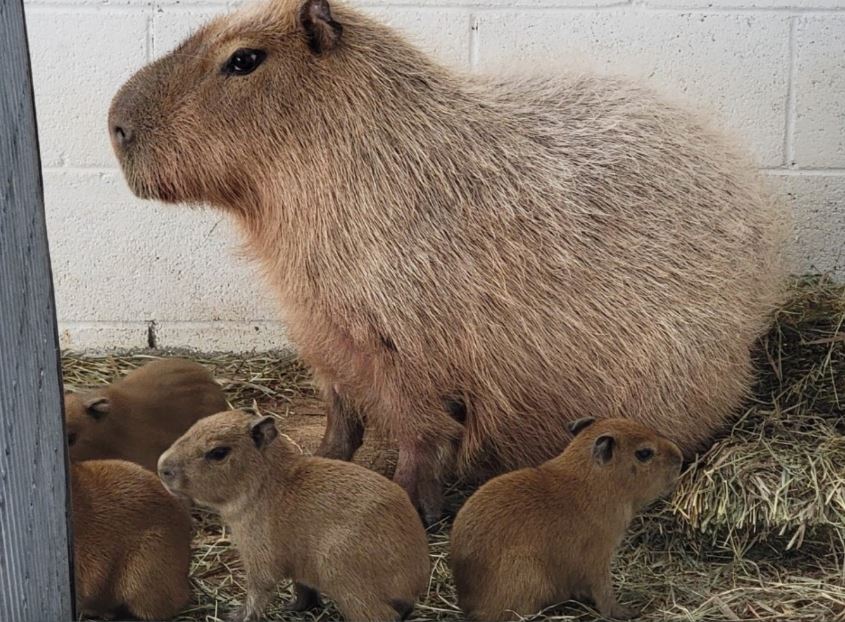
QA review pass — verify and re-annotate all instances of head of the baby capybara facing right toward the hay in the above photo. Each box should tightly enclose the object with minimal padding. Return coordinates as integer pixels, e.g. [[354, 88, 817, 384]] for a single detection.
[[566, 417, 683, 508]]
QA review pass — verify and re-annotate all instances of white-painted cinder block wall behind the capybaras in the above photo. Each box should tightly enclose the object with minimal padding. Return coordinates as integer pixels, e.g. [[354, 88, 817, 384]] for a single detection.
[[21, 0, 845, 351]]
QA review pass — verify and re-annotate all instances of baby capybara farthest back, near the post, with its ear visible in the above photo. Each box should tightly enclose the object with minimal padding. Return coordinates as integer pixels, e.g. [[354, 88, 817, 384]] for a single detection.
[[65, 358, 227, 472]]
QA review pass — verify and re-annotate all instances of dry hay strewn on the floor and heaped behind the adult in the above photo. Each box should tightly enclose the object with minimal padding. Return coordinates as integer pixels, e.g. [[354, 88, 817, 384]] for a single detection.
[[64, 277, 845, 622]]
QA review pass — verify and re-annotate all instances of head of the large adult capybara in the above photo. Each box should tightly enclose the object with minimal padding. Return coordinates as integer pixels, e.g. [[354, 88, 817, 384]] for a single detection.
[[109, 0, 362, 207]]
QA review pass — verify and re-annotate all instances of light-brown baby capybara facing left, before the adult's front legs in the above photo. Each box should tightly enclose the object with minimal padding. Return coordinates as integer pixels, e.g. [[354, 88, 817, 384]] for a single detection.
[[159, 411, 429, 622]]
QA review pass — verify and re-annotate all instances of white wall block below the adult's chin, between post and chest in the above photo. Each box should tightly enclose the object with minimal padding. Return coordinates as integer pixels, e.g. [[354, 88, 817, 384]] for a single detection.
[[45, 171, 278, 322]]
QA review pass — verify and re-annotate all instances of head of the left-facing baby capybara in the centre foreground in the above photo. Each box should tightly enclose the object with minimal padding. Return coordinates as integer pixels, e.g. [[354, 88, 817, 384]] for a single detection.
[[158, 411, 281, 508]]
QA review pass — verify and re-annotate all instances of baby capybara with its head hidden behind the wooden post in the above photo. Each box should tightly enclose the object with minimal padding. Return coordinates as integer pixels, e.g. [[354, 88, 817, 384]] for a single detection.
[[70, 460, 191, 620]]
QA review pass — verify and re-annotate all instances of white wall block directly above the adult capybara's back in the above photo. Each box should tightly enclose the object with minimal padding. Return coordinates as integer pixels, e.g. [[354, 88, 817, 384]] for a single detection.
[[477, 9, 789, 167]]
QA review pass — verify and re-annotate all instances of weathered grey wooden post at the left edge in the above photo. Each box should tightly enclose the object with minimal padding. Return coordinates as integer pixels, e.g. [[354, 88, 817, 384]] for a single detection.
[[0, 0, 73, 622]]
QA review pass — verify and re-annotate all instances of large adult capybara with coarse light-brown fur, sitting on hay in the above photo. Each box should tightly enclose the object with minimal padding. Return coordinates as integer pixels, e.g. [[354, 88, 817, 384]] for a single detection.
[[109, 0, 782, 518]]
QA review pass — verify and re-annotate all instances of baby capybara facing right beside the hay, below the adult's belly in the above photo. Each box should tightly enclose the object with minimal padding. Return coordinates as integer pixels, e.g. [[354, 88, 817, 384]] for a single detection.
[[449, 418, 683, 622]]
